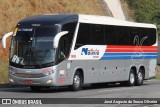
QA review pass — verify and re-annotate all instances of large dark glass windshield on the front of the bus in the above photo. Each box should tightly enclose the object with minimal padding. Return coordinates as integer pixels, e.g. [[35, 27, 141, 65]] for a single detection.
[[10, 26, 58, 66]]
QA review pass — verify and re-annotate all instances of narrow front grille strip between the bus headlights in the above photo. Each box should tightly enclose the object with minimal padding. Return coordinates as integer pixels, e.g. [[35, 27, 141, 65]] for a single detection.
[[14, 73, 45, 78]]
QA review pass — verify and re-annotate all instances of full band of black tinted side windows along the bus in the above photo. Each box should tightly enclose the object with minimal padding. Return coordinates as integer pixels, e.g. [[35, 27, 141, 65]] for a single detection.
[[75, 23, 156, 49]]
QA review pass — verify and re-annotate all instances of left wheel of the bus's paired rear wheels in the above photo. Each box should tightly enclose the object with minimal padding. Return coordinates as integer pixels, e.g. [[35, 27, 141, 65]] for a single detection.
[[127, 69, 136, 86]]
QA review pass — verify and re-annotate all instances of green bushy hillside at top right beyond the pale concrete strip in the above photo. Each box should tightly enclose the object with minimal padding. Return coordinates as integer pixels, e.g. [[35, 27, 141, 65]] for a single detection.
[[121, 0, 160, 25]]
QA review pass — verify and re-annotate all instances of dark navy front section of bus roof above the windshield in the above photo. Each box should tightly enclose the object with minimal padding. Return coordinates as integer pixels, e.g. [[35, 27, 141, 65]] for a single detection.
[[18, 14, 78, 26]]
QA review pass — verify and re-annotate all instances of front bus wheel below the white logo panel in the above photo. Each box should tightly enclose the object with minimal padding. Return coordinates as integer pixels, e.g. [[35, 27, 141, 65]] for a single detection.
[[70, 71, 82, 91]]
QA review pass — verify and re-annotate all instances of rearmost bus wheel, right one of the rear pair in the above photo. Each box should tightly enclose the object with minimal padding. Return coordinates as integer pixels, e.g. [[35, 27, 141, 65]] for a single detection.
[[136, 69, 144, 86]]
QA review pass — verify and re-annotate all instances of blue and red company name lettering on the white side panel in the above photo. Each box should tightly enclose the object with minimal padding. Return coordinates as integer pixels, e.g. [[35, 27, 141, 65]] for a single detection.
[[81, 48, 99, 55]]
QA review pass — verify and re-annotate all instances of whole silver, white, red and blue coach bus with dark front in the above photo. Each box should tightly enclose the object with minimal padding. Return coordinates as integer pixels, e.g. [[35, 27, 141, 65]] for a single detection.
[[2, 14, 158, 91]]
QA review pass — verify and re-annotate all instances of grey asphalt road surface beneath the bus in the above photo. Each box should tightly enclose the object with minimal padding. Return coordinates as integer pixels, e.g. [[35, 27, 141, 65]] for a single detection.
[[0, 80, 160, 107]]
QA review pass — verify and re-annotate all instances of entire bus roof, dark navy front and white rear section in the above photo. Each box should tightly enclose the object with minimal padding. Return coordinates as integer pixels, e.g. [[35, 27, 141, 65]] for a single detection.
[[18, 14, 156, 28]]
